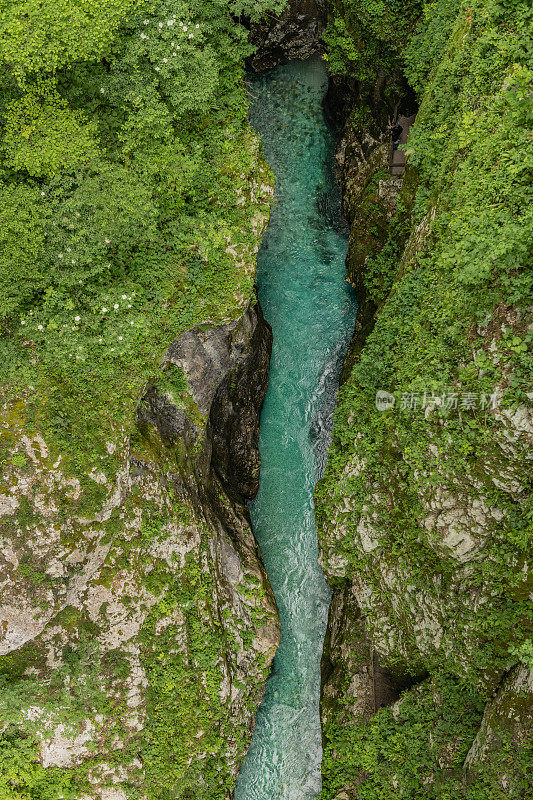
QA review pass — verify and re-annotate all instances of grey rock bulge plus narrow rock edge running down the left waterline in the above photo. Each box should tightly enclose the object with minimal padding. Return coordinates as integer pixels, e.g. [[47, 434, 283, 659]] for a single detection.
[[133, 300, 279, 774]]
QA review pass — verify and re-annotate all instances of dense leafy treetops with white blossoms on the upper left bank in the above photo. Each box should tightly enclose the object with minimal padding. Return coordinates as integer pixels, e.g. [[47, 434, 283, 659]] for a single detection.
[[0, 0, 280, 482]]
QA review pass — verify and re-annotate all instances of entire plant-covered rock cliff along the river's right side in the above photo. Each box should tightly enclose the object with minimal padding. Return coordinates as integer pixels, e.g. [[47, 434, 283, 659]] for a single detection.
[[316, 0, 533, 800]]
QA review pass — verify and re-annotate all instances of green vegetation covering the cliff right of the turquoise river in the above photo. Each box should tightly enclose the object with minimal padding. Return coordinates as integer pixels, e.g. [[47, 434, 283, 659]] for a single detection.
[[316, 0, 533, 800]]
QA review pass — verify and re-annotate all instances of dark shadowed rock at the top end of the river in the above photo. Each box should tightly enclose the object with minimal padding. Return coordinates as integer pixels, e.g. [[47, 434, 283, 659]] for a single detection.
[[250, 0, 327, 72]]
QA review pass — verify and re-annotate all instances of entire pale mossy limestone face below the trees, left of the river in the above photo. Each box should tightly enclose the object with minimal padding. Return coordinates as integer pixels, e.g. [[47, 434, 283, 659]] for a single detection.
[[0, 300, 279, 800]]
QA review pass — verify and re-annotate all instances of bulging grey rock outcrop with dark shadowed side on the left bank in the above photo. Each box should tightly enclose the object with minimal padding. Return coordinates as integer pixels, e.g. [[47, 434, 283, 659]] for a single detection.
[[138, 301, 272, 499]]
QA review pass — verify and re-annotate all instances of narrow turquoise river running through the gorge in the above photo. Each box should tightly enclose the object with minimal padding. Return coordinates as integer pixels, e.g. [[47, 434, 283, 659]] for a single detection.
[[235, 58, 355, 800]]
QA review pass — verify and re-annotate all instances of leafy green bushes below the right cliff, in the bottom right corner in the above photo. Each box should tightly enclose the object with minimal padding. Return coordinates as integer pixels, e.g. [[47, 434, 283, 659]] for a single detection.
[[321, 674, 533, 800]]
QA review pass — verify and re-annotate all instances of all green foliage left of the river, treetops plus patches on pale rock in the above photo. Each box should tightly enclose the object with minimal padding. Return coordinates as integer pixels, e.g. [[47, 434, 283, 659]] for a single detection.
[[0, 0, 284, 800]]
